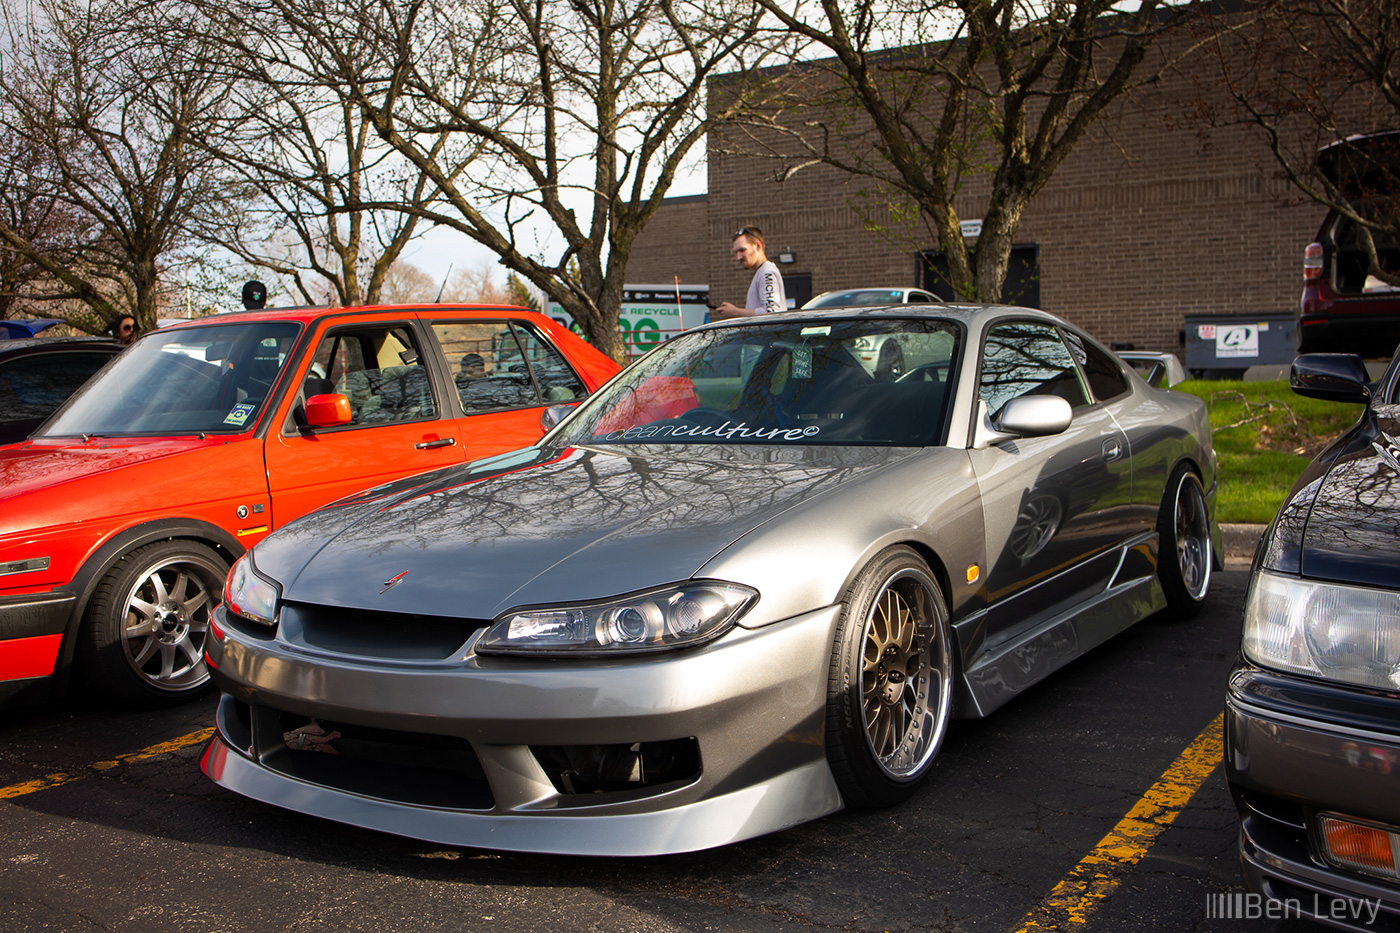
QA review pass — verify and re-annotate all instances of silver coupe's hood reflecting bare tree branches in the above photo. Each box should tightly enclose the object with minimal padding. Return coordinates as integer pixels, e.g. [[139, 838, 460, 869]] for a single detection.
[[253, 447, 913, 619]]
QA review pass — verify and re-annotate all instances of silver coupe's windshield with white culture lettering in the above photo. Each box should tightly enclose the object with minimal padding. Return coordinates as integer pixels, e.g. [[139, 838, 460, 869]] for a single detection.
[[552, 319, 959, 447]]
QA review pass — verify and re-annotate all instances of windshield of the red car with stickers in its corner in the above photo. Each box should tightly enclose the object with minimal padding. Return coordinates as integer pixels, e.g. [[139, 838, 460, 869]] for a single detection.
[[39, 321, 300, 437]]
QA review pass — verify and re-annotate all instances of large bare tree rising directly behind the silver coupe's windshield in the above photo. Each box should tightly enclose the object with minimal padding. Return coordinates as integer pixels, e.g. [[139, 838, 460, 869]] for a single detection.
[[214, 0, 789, 359]]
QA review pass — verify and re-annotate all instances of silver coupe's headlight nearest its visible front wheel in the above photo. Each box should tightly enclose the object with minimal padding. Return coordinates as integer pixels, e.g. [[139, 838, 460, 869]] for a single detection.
[[476, 580, 759, 657]]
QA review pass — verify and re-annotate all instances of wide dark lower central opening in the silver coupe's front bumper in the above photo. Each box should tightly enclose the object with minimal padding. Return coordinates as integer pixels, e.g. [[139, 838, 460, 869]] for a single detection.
[[259, 710, 494, 810]]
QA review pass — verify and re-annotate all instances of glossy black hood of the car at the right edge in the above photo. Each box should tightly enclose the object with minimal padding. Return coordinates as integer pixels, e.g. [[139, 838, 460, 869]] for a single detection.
[[1280, 417, 1400, 588]]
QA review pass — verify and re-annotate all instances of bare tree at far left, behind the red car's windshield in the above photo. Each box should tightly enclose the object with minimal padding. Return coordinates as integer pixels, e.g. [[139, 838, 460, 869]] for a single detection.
[[0, 0, 239, 331]]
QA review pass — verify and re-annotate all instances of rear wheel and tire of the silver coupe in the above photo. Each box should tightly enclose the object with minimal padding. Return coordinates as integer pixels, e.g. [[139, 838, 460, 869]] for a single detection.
[[1156, 464, 1212, 619]]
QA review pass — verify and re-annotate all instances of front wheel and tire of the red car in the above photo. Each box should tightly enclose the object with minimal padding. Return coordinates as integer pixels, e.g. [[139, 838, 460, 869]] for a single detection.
[[78, 541, 228, 706]]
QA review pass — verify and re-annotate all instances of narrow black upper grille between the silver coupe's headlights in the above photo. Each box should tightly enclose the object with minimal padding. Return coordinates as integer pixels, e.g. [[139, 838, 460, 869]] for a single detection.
[[281, 602, 490, 661]]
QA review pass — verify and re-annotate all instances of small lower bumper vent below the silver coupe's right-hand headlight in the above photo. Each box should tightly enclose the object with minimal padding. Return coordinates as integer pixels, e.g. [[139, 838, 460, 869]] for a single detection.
[[529, 738, 700, 794]]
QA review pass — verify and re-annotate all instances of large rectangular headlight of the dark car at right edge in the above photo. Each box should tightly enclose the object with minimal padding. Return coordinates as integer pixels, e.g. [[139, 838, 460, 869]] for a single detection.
[[1243, 573, 1400, 691]]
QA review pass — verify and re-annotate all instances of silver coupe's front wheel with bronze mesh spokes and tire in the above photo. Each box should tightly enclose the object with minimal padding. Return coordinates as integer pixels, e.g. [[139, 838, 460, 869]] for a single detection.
[[826, 546, 953, 807]]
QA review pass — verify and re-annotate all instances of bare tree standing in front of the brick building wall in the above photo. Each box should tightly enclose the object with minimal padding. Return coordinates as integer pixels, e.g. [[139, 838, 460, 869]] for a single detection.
[[741, 0, 1194, 301]]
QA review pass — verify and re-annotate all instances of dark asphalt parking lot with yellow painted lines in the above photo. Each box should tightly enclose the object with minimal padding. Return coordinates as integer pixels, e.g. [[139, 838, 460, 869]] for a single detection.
[[0, 545, 1316, 933]]
